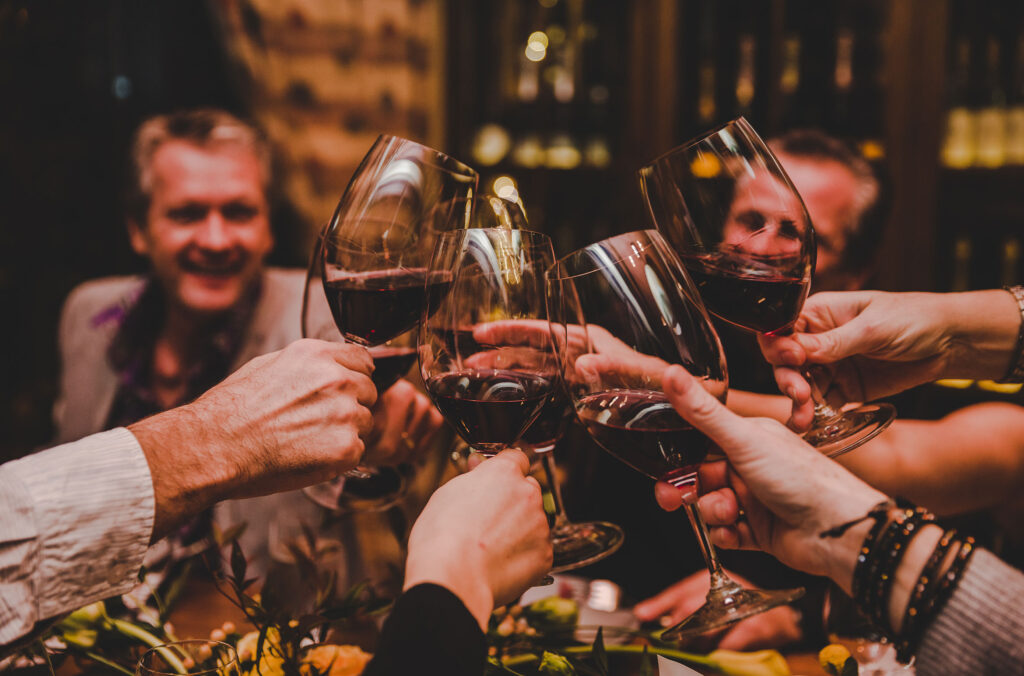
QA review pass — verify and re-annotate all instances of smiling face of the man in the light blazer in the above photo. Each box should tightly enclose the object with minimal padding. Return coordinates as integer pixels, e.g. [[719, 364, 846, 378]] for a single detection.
[[129, 140, 273, 314]]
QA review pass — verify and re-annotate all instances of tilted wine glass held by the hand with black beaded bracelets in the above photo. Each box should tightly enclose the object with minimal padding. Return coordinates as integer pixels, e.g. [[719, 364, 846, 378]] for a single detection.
[[547, 230, 803, 640]]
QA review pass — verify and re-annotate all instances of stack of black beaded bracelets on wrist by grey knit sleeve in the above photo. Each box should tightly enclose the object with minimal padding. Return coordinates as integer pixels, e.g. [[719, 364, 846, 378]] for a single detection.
[[821, 500, 975, 663]]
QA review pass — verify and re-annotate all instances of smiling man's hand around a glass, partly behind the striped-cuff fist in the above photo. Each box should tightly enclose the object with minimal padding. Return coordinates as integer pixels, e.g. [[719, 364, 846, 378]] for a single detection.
[[362, 380, 443, 465]]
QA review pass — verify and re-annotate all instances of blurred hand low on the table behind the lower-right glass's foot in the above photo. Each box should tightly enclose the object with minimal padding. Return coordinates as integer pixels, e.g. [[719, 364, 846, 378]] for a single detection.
[[633, 571, 801, 650]]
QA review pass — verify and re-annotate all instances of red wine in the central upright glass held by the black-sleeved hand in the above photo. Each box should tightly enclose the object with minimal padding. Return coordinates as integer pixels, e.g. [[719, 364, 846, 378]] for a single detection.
[[426, 369, 554, 453]]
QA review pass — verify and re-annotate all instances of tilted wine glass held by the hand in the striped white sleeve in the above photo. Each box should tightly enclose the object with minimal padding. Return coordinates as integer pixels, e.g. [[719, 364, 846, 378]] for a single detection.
[[303, 134, 478, 509]]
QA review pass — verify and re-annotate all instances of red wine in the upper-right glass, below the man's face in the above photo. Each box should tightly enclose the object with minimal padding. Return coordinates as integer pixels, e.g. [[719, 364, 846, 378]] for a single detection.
[[680, 252, 809, 333]]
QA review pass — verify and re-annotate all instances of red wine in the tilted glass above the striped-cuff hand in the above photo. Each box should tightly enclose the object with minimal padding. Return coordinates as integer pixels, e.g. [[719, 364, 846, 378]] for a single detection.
[[324, 267, 452, 345]]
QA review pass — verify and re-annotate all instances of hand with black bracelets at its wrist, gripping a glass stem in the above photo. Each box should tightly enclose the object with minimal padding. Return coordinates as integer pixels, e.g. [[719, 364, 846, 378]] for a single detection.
[[655, 366, 885, 586]]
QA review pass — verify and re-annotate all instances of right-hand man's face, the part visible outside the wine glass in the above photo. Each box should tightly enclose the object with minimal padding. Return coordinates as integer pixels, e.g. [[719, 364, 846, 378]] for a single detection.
[[778, 153, 858, 291]]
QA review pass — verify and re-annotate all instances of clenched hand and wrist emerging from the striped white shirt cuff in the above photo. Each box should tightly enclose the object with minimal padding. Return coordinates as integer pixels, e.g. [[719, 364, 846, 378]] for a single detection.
[[129, 340, 377, 535]]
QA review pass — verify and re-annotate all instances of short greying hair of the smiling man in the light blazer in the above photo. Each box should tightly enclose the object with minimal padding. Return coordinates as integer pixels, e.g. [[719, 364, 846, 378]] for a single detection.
[[125, 108, 270, 226]]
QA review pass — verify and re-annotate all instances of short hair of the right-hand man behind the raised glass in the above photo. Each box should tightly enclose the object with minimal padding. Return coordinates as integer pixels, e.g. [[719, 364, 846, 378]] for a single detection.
[[768, 129, 888, 272]]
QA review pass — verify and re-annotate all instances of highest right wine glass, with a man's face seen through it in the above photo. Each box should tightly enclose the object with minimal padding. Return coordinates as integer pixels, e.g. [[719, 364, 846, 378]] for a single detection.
[[639, 118, 896, 457]]
